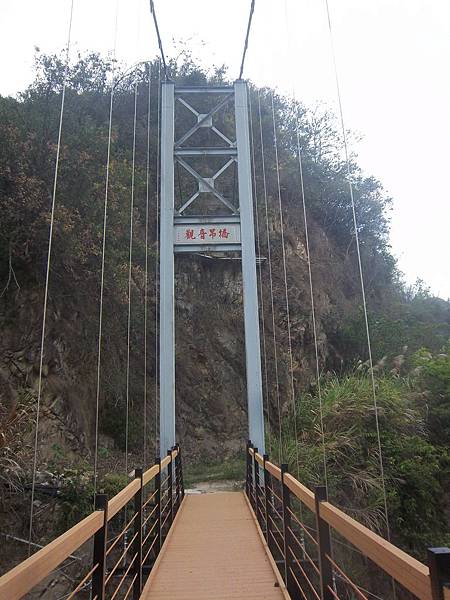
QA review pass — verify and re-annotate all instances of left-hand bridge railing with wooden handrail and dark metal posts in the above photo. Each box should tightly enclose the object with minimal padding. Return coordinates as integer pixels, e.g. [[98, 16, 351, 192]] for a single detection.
[[0, 445, 184, 600]]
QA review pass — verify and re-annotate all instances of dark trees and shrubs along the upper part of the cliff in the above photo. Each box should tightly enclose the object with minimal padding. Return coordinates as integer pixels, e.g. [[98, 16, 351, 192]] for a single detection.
[[0, 49, 400, 458]]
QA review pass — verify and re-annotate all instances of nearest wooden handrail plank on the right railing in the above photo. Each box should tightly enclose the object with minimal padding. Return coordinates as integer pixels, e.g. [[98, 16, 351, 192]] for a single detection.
[[320, 502, 432, 600]]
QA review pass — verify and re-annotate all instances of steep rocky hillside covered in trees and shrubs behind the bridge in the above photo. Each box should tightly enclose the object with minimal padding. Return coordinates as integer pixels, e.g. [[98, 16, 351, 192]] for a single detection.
[[0, 49, 450, 568]]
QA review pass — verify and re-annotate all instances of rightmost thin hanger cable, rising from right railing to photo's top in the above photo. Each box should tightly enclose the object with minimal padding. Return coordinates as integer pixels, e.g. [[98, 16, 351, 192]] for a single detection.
[[325, 0, 395, 540]]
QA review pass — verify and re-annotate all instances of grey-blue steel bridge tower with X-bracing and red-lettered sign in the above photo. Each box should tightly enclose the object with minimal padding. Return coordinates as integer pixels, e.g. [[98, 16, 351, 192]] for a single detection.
[[160, 80, 264, 456]]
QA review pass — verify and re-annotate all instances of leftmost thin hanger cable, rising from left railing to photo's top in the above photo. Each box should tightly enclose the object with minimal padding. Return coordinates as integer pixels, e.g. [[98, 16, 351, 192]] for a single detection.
[[28, 0, 74, 555]]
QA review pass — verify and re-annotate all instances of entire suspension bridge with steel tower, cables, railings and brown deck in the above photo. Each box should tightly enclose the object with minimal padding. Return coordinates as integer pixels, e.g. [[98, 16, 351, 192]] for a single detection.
[[0, 0, 450, 600]]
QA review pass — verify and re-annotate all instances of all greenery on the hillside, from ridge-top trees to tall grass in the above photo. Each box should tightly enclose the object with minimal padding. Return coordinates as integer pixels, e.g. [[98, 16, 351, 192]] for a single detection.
[[0, 50, 450, 564]]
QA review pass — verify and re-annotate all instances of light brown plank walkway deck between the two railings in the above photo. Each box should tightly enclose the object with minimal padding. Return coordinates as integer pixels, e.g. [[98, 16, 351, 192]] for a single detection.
[[141, 492, 289, 600]]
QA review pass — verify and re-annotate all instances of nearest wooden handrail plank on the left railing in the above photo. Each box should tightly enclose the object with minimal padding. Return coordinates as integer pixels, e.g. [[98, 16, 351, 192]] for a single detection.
[[0, 510, 103, 600]]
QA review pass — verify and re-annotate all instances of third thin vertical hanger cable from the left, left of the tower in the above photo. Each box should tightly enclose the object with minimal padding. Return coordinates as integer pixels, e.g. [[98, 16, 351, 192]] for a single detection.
[[125, 77, 138, 475]]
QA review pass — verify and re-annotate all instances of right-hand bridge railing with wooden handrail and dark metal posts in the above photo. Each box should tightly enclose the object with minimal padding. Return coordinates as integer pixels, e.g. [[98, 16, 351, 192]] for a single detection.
[[246, 442, 450, 600]]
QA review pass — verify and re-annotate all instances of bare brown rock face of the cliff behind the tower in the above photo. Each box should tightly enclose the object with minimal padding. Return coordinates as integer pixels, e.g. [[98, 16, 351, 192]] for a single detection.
[[0, 207, 357, 472]]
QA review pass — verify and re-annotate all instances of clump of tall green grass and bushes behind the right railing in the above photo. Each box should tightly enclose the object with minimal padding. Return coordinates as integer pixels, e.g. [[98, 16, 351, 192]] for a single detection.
[[283, 371, 450, 554]]
